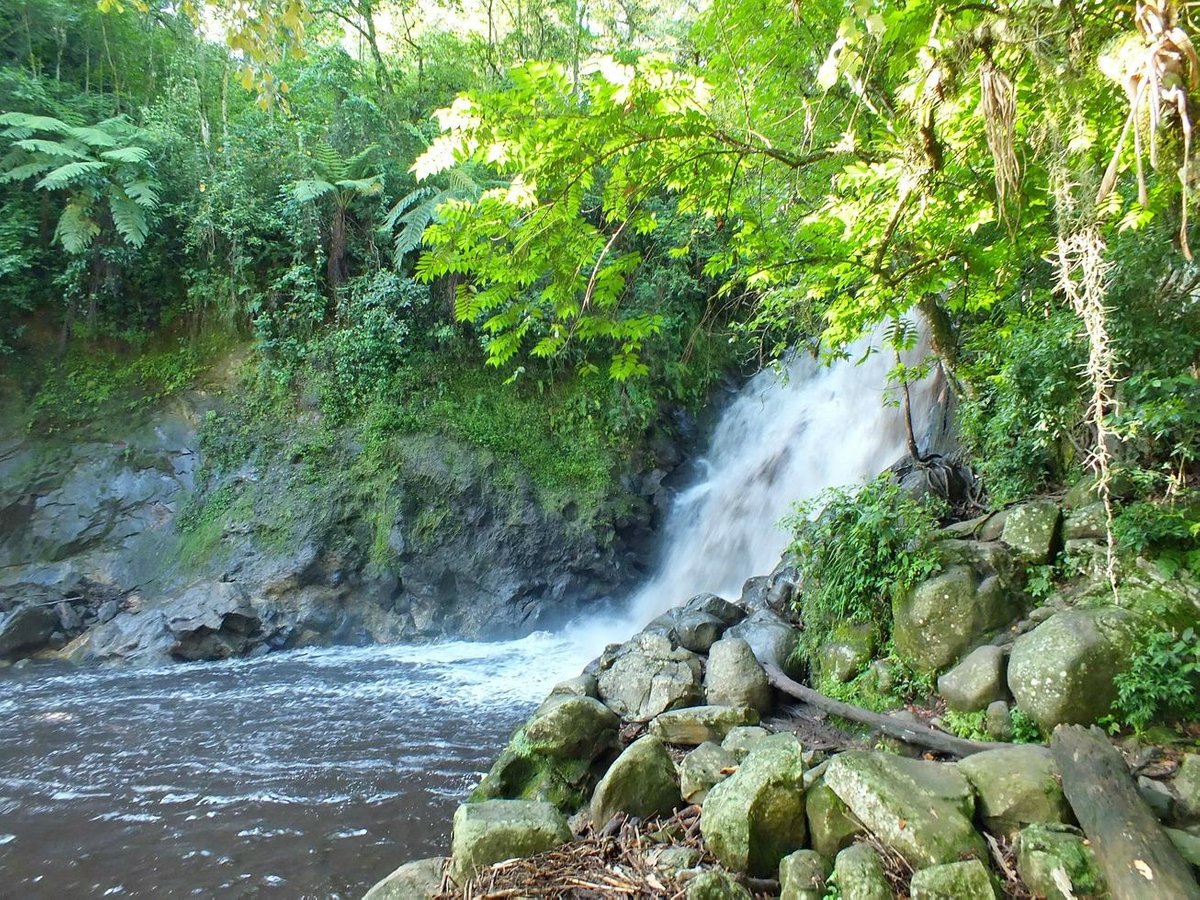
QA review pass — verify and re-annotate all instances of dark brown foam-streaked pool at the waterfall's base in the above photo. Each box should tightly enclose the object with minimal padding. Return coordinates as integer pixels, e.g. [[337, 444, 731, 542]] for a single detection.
[[0, 634, 597, 898]]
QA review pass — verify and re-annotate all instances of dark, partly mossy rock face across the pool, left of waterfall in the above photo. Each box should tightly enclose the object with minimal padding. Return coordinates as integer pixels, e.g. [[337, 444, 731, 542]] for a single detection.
[[0, 369, 683, 662]]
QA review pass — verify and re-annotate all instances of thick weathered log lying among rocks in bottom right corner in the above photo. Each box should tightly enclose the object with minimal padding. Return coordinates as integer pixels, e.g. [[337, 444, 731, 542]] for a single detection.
[[1050, 725, 1200, 900]]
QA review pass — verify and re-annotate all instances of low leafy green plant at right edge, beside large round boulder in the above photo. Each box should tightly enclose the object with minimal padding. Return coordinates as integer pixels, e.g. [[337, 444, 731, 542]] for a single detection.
[[1109, 628, 1200, 733]]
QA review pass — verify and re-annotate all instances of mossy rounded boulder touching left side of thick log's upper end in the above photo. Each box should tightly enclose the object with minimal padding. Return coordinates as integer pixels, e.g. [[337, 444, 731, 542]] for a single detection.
[[958, 744, 1070, 836]]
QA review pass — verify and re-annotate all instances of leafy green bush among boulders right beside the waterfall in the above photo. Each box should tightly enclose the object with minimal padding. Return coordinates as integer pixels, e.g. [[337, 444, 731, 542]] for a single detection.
[[782, 476, 941, 650]]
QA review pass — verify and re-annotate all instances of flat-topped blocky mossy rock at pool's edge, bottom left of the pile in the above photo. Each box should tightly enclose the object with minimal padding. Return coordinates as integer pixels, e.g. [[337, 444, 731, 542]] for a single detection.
[[450, 800, 571, 884]]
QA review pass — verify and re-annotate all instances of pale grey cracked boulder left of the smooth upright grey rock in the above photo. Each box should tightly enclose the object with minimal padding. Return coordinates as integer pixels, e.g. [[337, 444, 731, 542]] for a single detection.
[[598, 634, 701, 722]]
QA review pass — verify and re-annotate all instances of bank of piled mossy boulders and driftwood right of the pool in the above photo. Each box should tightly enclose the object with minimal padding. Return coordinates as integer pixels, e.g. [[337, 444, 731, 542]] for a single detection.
[[367, 494, 1200, 900]]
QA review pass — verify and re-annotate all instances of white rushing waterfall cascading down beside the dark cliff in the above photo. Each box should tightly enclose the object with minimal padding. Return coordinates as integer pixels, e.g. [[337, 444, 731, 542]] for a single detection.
[[578, 336, 932, 646]]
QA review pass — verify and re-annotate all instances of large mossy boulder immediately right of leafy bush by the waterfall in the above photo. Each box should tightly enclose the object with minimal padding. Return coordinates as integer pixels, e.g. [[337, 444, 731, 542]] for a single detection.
[[892, 565, 1015, 673]]
